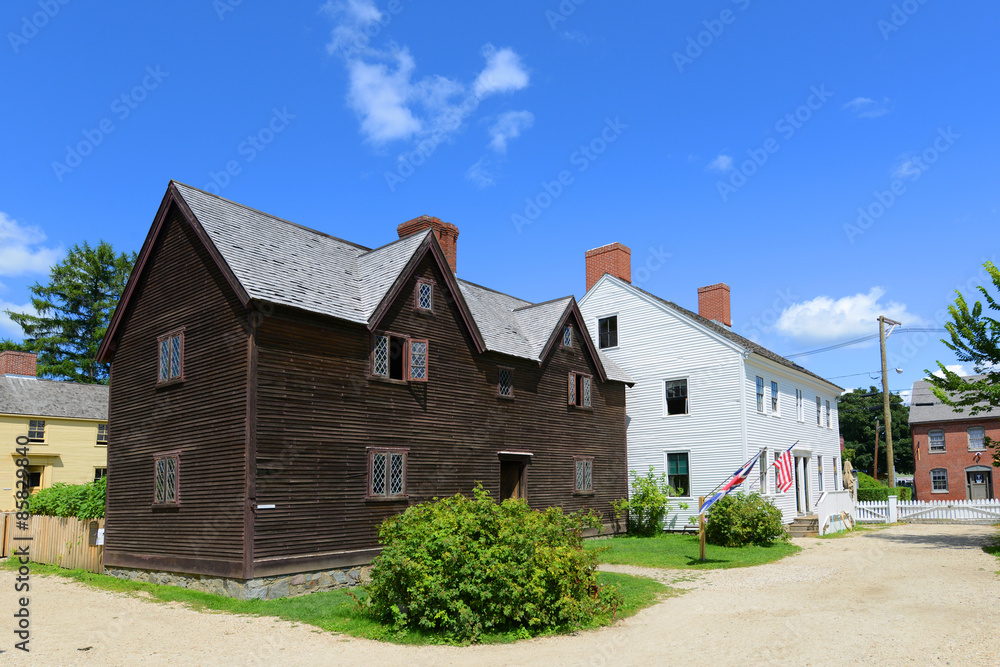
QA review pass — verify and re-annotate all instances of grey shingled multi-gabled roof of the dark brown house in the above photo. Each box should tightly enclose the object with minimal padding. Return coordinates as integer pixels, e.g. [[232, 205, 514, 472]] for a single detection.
[[98, 181, 632, 382]]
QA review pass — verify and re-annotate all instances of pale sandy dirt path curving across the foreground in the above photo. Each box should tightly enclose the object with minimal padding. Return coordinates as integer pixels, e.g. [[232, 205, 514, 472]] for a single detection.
[[0, 525, 1000, 667]]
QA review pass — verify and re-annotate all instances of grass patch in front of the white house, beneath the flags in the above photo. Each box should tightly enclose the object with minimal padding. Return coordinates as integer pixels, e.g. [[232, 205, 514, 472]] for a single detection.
[[584, 533, 801, 570]]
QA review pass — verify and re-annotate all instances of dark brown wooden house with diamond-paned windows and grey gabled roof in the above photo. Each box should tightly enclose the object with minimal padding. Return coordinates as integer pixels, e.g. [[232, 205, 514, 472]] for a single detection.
[[99, 182, 631, 597]]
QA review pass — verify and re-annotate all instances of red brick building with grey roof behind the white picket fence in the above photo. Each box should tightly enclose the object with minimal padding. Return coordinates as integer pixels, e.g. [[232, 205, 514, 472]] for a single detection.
[[910, 381, 1000, 500]]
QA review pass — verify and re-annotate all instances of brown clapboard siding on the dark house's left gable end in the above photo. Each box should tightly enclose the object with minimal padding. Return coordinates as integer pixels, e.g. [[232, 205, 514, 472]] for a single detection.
[[105, 206, 247, 574]]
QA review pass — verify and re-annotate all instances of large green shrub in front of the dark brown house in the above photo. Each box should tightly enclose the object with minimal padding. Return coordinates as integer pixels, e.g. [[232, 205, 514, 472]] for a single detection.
[[363, 485, 620, 641]]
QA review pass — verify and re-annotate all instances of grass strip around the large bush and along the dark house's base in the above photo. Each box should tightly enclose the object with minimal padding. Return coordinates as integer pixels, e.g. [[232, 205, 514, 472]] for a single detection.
[[2, 559, 676, 644]]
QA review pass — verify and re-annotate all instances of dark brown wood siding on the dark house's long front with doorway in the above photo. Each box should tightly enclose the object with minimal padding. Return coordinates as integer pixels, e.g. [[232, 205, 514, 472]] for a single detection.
[[254, 258, 627, 576]]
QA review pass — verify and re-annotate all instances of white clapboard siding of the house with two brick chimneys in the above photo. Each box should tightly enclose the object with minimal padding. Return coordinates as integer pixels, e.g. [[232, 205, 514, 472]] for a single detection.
[[580, 277, 839, 529]]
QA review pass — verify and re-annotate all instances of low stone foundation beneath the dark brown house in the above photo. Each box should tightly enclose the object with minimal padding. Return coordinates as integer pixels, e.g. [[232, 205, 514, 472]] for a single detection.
[[104, 565, 371, 600]]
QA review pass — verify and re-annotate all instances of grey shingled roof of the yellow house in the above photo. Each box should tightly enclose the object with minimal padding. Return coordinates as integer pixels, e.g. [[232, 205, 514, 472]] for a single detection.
[[0, 375, 108, 420]]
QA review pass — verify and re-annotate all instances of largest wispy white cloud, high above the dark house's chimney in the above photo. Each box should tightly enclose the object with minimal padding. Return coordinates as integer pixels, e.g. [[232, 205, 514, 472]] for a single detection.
[[323, 6, 529, 146]]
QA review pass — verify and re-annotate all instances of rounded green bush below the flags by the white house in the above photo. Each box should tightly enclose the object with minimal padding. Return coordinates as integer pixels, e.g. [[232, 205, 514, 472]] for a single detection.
[[705, 492, 788, 547]]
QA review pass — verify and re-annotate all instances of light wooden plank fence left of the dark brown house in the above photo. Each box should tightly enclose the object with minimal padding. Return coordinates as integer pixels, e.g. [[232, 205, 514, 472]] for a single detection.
[[0, 512, 104, 573]]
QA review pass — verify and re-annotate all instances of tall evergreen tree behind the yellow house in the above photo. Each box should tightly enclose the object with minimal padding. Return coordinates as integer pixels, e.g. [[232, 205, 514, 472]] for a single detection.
[[7, 241, 136, 384]]
